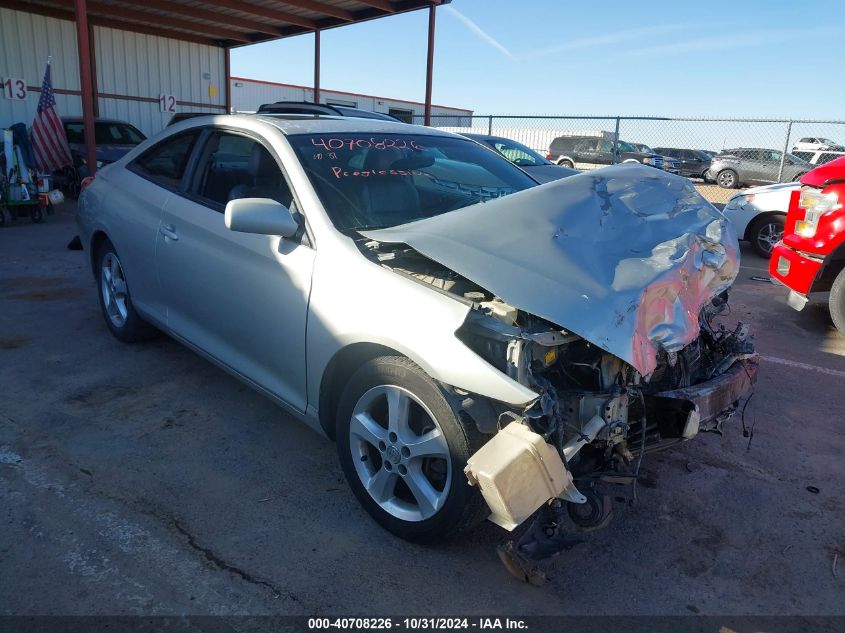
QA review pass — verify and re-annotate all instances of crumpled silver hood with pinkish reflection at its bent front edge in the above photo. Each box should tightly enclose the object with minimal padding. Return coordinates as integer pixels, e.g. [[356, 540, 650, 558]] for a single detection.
[[364, 164, 739, 375]]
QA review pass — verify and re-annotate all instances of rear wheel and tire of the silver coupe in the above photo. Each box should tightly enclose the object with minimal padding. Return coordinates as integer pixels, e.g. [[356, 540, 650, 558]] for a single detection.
[[97, 240, 157, 343]]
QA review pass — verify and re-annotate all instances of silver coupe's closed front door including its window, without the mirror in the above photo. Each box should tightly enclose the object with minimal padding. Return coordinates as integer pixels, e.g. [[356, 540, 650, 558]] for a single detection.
[[156, 129, 315, 411]]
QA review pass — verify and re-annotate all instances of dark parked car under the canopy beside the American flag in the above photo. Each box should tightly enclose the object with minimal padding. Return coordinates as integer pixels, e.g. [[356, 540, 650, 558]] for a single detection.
[[54, 117, 147, 198]]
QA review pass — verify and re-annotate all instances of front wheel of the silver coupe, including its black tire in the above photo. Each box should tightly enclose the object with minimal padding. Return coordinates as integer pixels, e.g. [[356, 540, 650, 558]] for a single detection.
[[337, 356, 486, 542]]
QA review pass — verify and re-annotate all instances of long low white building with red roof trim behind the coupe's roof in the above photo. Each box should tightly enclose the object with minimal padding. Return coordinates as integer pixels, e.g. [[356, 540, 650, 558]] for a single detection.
[[229, 77, 472, 126]]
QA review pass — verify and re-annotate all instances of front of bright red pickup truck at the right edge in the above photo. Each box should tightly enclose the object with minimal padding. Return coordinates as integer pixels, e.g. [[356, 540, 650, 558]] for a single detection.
[[769, 158, 845, 334]]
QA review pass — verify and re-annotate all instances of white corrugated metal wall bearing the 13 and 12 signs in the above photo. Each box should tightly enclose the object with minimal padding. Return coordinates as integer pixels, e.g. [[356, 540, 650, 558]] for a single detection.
[[0, 8, 226, 135]]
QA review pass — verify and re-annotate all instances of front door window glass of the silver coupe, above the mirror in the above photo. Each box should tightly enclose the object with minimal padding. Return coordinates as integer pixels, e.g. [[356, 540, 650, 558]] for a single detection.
[[193, 132, 293, 212]]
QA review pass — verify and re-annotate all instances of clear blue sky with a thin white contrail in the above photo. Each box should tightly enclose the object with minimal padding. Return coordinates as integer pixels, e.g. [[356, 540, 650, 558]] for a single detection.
[[232, 0, 845, 119]]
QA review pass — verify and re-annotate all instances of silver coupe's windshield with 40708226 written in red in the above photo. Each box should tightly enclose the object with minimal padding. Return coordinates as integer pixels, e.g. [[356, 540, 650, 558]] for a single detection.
[[288, 134, 537, 231]]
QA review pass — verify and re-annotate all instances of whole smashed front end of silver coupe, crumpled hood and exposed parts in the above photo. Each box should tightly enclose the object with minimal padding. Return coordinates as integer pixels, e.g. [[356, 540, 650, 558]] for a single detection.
[[364, 165, 758, 568]]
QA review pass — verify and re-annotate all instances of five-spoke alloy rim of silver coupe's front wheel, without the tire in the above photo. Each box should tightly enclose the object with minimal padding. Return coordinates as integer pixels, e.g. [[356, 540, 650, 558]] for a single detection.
[[349, 385, 452, 521]]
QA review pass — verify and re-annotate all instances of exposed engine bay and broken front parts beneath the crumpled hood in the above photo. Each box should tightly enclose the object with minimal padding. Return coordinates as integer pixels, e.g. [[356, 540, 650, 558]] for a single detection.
[[361, 241, 757, 575]]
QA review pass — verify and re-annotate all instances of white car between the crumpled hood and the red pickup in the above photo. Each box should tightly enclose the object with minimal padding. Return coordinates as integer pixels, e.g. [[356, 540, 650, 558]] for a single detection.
[[722, 182, 801, 258]]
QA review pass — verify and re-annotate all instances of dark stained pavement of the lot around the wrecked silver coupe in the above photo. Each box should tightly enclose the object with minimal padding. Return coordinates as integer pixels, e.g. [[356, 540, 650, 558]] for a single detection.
[[0, 201, 845, 615]]
